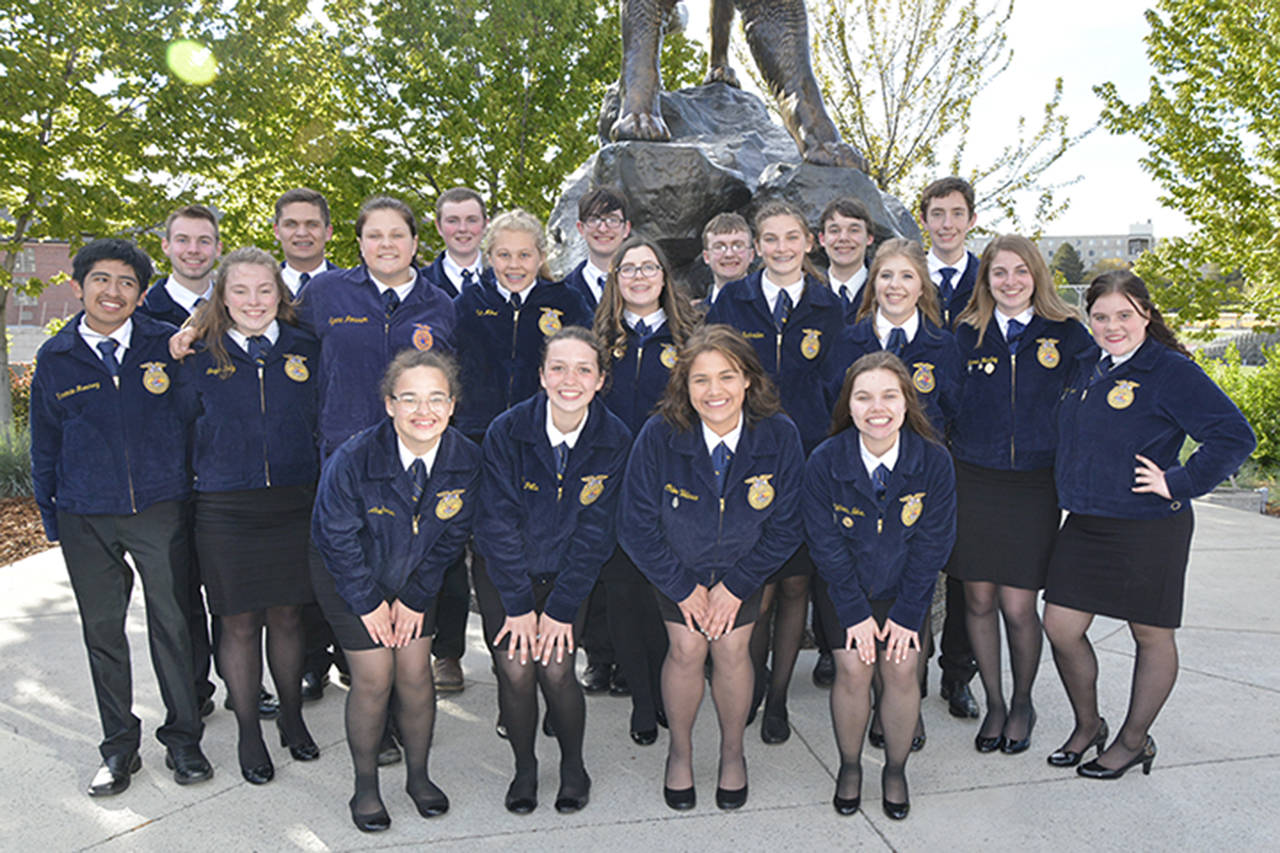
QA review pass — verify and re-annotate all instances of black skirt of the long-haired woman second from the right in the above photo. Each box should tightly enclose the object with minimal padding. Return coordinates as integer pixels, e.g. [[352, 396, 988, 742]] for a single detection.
[[946, 460, 1062, 589]]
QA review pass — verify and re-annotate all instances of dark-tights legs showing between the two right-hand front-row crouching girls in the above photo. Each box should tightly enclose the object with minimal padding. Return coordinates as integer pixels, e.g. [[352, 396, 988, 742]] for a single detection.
[[750, 575, 809, 716]]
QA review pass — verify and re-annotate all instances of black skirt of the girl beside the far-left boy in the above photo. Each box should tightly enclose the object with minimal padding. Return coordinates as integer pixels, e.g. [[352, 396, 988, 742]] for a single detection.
[[196, 485, 315, 616]]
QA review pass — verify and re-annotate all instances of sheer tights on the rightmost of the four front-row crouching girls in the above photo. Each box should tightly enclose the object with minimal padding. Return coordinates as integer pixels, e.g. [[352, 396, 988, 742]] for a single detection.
[[831, 649, 920, 803]]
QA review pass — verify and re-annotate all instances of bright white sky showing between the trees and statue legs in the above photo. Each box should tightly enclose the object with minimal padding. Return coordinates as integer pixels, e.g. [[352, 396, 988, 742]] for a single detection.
[[686, 0, 1189, 238]]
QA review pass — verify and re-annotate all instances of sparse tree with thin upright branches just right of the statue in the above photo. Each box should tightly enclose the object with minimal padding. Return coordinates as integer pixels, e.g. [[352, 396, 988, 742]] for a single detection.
[[757, 0, 1092, 228]]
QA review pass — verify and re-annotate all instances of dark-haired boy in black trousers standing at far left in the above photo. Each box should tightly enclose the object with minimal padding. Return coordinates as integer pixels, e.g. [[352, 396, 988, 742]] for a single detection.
[[31, 240, 214, 797]]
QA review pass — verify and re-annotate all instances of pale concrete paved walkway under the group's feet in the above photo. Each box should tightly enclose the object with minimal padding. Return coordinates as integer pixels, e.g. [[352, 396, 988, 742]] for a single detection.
[[0, 505, 1280, 853]]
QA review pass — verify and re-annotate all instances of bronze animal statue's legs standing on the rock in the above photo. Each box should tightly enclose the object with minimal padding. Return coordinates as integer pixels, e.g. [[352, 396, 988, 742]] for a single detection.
[[602, 0, 867, 172]]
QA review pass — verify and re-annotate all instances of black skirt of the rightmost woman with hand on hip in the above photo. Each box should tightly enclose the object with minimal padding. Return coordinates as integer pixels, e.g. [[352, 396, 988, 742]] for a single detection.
[[1044, 506, 1196, 628]]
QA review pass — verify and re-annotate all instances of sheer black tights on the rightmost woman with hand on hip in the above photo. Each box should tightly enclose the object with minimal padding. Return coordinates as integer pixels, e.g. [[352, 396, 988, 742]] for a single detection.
[[1044, 605, 1178, 768]]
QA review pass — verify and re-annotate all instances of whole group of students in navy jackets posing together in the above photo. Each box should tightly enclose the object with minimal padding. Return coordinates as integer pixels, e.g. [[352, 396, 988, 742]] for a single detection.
[[31, 178, 1253, 831]]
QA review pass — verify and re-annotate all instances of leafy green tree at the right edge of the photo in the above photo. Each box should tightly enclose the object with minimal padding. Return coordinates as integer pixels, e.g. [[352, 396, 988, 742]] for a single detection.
[[1094, 0, 1280, 324]]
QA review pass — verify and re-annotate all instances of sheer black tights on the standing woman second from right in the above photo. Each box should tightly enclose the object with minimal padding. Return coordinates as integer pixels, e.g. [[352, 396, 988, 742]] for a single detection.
[[964, 580, 1043, 740]]
